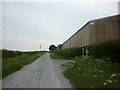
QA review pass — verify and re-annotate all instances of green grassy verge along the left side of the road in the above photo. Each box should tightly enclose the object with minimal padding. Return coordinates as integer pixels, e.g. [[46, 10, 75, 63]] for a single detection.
[[2, 51, 45, 78]]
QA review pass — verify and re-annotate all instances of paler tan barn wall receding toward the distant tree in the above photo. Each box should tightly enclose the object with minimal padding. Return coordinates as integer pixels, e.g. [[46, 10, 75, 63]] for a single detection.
[[63, 23, 89, 49]]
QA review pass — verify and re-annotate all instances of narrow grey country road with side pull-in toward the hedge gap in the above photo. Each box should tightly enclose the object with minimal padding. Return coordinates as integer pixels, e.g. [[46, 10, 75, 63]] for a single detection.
[[3, 53, 71, 88]]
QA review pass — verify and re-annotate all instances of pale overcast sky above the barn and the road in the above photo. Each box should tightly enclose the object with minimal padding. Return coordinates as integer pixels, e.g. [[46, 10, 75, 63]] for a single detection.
[[0, 0, 119, 51]]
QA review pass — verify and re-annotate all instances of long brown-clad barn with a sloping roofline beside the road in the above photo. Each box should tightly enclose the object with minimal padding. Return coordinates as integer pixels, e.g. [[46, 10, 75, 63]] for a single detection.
[[63, 14, 120, 54]]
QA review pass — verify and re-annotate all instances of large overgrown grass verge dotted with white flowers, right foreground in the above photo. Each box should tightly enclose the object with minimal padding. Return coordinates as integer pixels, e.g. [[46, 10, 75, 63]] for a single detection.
[[62, 57, 120, 88]]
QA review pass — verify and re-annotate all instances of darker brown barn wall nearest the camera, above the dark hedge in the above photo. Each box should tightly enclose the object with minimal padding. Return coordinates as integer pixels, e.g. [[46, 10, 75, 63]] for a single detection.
[[89, 16, 120, 44]]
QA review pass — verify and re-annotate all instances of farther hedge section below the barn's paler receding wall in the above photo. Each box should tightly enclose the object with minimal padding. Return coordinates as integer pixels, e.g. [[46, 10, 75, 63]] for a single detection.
[[54, 48, 82, 58]]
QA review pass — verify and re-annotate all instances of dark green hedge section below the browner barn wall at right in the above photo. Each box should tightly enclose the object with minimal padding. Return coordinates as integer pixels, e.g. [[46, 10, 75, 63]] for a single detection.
[[88, 40, 120, 62]]
